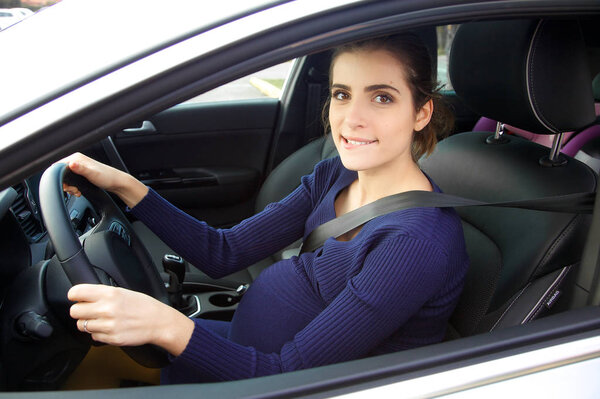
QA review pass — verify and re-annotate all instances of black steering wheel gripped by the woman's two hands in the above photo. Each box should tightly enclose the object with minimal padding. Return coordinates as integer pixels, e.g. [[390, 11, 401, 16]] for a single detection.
[[40, 163, 169, 368]]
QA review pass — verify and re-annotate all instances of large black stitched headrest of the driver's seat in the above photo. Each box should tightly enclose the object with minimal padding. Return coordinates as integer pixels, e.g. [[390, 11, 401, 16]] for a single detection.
[[450, 20, 595, 134]]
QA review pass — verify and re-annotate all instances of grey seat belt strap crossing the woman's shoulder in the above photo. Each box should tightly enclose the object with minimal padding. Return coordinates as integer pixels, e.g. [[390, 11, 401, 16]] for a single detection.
[[300, 191, 596, 254]]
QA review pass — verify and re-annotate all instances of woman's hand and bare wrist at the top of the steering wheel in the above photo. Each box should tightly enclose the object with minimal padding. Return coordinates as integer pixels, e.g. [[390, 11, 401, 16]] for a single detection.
[[61, 153, 148, 208]]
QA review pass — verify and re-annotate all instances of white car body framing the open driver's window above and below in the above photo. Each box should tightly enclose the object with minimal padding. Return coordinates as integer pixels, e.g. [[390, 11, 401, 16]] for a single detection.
[[0, 0, 600, 398]]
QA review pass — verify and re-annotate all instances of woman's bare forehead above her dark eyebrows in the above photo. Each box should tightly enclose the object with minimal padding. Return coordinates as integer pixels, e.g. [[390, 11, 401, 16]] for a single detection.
[[331, 50, 405, 86]]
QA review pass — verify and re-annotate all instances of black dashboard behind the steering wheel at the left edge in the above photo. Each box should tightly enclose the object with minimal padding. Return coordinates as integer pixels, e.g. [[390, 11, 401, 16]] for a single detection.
[[0, 175, 99, 389]]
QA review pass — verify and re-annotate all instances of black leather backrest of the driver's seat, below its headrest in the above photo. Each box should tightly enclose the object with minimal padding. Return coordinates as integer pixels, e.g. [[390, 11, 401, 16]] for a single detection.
[[421, 132, 596, 336]]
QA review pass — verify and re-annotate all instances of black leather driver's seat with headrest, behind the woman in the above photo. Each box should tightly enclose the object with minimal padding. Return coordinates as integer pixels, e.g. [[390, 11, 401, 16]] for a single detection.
[[421, 20, 597, 337]]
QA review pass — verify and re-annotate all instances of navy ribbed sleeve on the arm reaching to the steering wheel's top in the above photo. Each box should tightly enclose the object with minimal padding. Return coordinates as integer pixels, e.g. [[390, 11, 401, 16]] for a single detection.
[[131, 162, 333, 278]]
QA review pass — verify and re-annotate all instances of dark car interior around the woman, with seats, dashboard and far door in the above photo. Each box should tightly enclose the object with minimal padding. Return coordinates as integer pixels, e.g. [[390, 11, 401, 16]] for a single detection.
[[0, 8, 600, 391]]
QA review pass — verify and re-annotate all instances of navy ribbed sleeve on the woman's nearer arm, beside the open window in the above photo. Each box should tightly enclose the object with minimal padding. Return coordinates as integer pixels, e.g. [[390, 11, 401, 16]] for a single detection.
[[171, 235, 448, 380]]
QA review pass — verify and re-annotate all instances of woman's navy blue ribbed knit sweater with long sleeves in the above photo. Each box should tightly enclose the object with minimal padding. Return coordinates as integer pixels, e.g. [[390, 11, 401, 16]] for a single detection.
[[132, 158, 468, 383]]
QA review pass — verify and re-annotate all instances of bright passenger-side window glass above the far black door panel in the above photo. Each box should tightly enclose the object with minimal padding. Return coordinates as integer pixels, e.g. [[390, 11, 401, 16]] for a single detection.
[[187, 60, 293, 103]]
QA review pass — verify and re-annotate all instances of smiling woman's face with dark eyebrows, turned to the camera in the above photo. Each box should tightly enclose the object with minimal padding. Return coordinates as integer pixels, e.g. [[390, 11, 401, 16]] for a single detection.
[[329, 50, 431, 171]]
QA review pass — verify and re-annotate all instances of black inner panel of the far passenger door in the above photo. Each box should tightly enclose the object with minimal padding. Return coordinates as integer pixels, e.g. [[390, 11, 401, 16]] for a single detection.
[[115, 98, 279, 226]]
